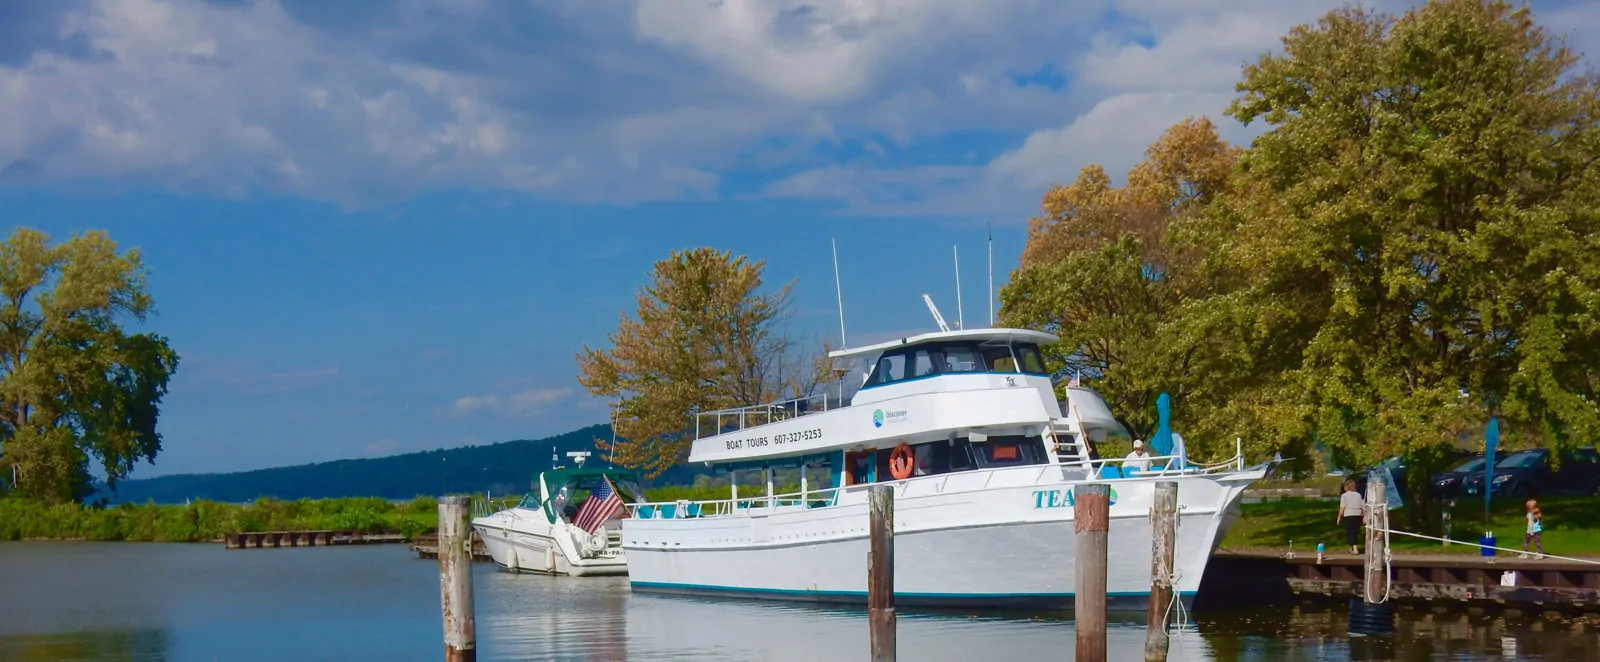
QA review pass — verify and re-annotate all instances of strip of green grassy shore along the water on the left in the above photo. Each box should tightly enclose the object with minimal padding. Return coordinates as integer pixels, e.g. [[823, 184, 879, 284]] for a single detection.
[[0, 497, 438, 542]]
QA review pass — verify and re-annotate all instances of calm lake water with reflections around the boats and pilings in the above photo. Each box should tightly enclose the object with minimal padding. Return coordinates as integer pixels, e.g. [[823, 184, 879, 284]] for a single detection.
[[0, 542, 1600, 662]]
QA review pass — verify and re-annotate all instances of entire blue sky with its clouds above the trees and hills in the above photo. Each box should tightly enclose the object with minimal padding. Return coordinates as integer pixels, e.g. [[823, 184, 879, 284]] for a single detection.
[[0, 0, 1600, 478]]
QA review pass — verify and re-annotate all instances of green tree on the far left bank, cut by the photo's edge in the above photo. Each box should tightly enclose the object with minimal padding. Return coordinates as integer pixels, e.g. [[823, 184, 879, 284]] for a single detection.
[[0, 227, 178, 500]]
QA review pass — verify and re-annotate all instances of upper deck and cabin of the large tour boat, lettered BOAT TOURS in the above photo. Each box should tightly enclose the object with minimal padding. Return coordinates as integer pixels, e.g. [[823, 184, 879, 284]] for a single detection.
[[643, 328, 1120, 514]]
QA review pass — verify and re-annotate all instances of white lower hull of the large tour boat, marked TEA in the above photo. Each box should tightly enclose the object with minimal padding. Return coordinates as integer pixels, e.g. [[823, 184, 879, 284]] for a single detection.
[[624, 477, 1248, 611]]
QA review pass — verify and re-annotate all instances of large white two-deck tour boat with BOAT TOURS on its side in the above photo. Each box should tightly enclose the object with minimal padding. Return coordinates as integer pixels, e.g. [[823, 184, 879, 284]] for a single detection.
[[622, 326, 1267, 611]]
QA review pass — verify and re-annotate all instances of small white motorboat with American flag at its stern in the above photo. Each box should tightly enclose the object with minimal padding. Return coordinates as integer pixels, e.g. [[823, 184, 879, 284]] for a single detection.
[[472, 463, 642, 576]]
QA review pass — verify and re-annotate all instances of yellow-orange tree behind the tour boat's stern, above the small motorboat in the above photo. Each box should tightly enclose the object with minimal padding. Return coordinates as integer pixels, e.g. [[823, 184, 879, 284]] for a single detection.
[[578, 248, 818, 477]]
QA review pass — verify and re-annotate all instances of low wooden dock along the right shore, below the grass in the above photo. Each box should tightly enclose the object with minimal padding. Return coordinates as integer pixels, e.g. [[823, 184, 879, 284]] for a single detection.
[[1208, 550, 1600, 611]]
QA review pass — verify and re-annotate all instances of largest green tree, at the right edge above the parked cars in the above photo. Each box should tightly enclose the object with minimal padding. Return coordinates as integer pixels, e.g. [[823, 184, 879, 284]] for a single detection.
[[1210, 0, 1600, 514]]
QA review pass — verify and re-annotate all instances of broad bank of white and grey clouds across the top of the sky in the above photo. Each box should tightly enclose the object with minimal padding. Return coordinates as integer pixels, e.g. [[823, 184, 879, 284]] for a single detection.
[[0, 0, 1600, 214]]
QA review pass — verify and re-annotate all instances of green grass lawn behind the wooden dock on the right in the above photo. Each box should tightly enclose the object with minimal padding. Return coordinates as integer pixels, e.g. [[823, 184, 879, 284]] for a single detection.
[[1222, 497, 1600, 556]]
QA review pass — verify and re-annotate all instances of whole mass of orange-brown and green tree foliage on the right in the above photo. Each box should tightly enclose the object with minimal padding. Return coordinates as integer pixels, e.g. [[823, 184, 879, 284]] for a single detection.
[[1002, 0, 1600, 497]]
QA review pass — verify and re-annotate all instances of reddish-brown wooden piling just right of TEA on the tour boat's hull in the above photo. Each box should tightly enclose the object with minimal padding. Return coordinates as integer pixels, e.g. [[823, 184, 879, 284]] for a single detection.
[[1070, 483, 1110, 662]]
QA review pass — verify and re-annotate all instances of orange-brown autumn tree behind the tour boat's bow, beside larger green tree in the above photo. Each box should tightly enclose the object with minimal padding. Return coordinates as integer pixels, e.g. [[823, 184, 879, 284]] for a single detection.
[[1000, 118, 1238, 444]]
